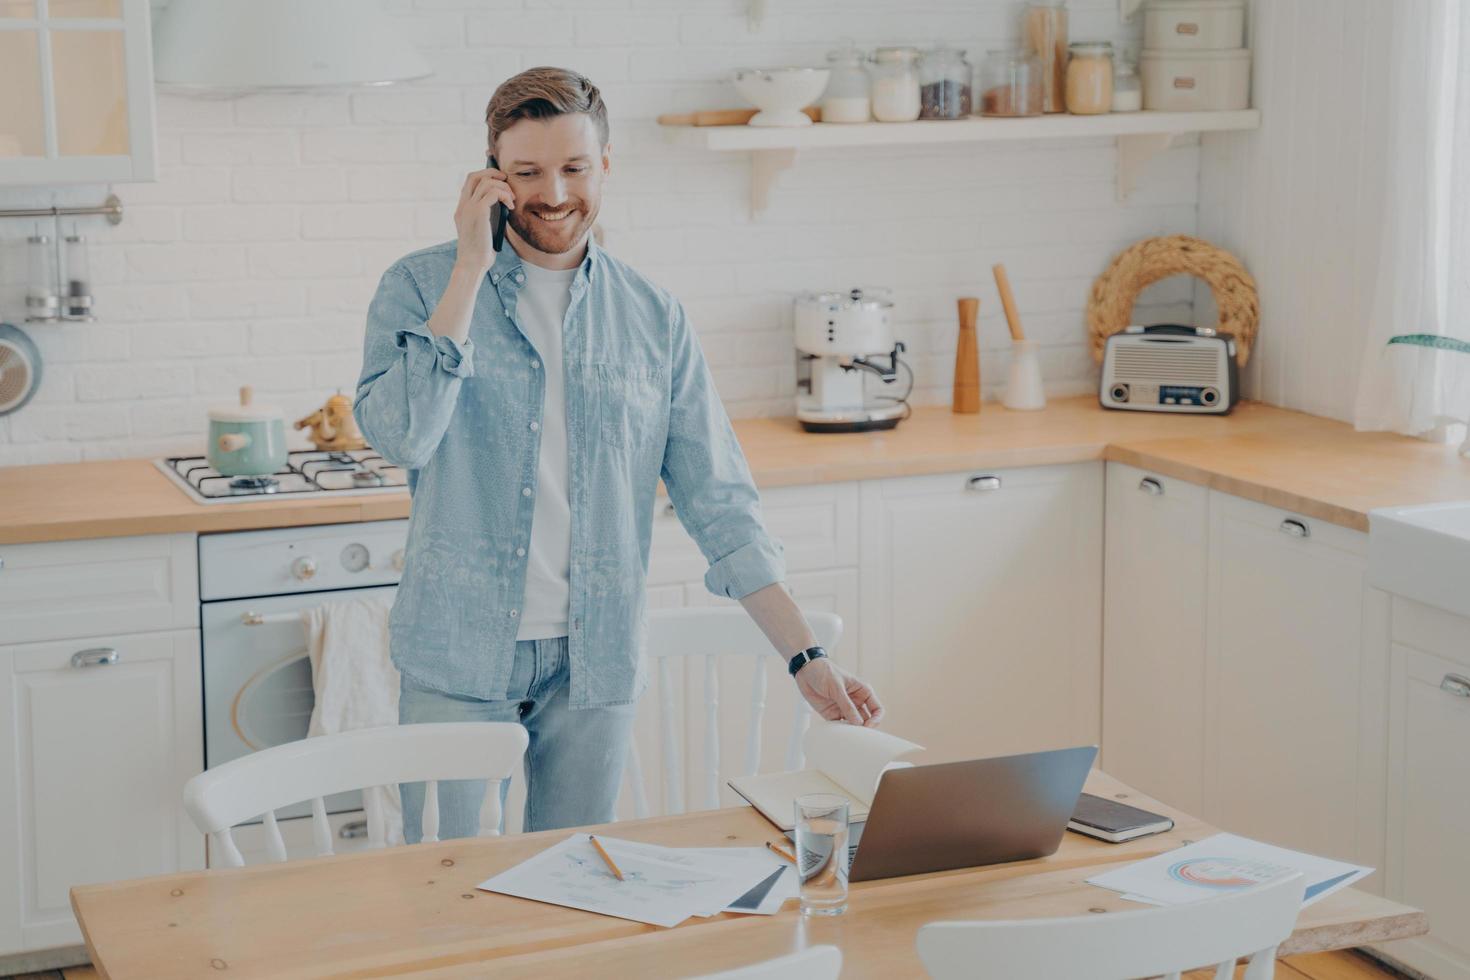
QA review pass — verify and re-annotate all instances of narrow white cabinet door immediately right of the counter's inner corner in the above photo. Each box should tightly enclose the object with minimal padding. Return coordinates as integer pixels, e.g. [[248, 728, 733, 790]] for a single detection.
[[1101, 463, 1210, 813]]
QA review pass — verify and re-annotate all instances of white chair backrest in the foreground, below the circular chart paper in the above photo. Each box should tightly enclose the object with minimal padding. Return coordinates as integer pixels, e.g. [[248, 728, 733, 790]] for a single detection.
[[919, 874, 1304, 980]]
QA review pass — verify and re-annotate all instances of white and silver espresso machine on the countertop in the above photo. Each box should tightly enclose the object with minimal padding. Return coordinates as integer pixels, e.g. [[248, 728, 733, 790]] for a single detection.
[[795, 289, 913, 432]]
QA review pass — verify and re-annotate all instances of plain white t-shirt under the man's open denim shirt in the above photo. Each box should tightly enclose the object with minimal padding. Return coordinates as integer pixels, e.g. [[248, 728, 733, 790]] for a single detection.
[[516, 262, 576, 641]]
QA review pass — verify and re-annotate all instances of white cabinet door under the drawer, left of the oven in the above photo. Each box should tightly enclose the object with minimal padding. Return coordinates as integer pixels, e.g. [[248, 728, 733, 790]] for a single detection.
[[0, 630, 204, 954]]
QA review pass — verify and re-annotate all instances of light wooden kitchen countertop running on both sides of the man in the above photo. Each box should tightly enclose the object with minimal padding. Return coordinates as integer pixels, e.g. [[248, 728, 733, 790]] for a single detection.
[[0, 398, 1470, 544]]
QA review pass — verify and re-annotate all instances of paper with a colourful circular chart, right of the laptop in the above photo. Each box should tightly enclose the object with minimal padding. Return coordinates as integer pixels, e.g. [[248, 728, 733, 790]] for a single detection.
[[1088, 833, 1373, 907]]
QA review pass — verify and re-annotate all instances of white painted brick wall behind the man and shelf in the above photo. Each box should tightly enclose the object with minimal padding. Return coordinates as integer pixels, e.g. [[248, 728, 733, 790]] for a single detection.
[[0, 0, 1200, 464]]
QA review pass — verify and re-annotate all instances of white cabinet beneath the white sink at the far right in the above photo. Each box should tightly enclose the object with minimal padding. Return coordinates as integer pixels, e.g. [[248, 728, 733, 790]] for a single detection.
[[1382, 598, 1470, 980]]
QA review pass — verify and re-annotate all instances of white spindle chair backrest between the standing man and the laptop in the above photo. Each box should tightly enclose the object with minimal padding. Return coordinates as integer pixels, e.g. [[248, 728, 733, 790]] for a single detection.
[[628, 605, 842, 817]]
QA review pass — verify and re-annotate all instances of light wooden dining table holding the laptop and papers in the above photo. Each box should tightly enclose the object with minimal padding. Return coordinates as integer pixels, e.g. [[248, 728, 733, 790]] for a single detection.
[[72, 771, 1429, 980]]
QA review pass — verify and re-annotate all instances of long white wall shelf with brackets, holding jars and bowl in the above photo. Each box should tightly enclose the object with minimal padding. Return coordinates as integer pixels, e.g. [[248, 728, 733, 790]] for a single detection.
[[664, 109, 1261, 213]]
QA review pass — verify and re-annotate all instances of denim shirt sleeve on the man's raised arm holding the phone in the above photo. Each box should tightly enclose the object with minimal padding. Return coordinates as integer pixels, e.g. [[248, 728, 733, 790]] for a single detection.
[[353, 266, 475, 469]]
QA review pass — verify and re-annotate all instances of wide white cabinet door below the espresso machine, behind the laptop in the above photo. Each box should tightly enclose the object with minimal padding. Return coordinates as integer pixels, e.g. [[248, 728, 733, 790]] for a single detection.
[[858, 463, 1103, 761]]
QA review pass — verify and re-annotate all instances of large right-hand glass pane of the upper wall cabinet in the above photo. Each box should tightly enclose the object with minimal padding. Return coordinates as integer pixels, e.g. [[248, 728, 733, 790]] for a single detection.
[[51, 31, 128, 156]]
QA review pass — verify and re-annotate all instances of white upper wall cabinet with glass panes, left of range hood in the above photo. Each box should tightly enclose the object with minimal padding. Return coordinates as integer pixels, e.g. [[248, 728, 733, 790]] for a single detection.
[[0, 0, 156, 187]]
